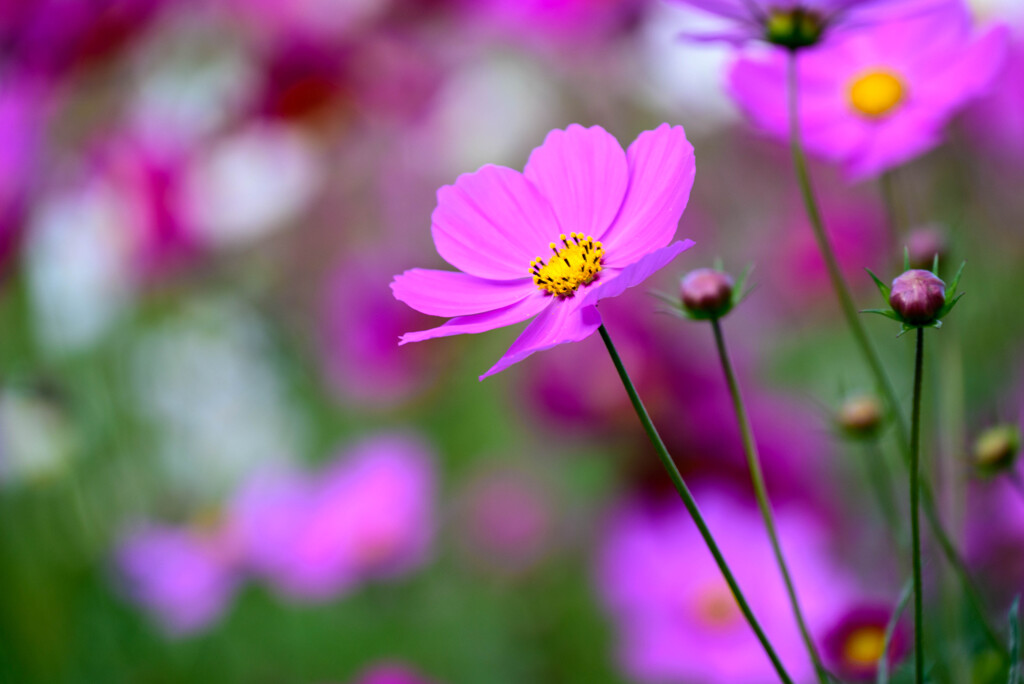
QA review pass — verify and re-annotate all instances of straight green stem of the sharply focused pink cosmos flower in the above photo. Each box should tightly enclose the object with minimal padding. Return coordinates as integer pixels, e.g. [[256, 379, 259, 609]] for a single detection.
[[598, 325, 793, 684]]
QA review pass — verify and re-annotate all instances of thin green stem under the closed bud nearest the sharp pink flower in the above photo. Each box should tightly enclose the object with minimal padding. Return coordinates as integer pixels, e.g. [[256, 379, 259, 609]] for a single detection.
[[711, 318, 828, 684]]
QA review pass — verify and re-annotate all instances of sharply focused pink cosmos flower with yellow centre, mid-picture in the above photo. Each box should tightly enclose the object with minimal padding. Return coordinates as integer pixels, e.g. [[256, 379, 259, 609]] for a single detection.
[[391, 124, 696, 380]]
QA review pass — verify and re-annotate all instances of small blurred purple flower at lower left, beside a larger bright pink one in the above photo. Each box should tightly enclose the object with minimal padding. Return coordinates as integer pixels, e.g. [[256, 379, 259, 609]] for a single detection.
[[115, 525, 239, 636]]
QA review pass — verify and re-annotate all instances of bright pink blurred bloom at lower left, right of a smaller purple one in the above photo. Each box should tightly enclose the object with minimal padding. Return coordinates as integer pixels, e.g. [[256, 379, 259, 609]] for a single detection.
[[232, 435, 434, 600]]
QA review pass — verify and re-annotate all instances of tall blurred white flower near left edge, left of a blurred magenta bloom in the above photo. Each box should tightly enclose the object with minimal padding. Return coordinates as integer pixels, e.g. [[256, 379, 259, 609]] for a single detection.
[[26, 180, 137, 354]]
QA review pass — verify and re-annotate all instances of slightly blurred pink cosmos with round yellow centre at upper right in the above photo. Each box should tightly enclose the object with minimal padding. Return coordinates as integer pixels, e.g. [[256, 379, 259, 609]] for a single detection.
[[729, 2, 1008, 180]]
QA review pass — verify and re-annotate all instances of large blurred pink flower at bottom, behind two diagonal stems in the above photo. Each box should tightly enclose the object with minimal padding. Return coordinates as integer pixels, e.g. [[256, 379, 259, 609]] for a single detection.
[[598, 493, 852, 684]]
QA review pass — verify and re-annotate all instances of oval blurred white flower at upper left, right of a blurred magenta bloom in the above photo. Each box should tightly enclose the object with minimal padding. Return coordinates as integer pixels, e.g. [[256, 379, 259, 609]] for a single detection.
[[178, 124, 323, 248]]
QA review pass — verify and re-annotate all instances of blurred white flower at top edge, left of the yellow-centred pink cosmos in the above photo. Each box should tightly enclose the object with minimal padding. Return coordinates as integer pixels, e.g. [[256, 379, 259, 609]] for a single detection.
[[637, 2, 738, 134]]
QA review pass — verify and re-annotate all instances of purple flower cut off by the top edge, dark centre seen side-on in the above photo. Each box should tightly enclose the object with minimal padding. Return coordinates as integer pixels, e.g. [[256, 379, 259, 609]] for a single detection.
[[670, 0, 945, 48]]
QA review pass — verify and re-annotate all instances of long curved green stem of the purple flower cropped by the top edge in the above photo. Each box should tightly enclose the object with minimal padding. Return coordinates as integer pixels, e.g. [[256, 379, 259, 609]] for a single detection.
[[788, 52, 1010, 659]]
